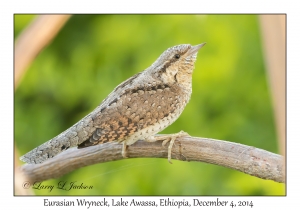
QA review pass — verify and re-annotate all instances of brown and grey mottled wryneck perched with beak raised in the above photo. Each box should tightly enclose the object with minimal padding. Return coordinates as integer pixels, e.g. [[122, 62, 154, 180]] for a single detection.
[[20, 43, 206, 164]]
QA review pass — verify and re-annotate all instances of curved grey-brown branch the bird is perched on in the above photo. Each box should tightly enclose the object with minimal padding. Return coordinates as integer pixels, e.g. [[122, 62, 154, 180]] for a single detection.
[[19, 136, 285, 183]]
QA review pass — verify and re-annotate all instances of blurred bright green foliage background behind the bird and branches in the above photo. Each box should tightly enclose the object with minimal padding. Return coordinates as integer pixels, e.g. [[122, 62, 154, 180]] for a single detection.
[[14, 15, 285, 195]]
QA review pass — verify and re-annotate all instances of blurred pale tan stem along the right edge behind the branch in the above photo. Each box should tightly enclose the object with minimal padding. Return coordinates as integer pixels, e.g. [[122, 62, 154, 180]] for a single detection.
[[259, 14, 286, 155]]
